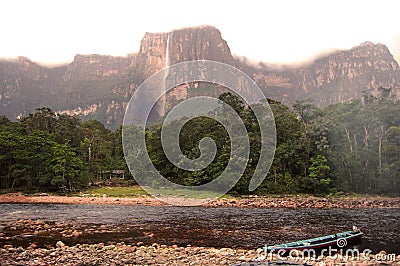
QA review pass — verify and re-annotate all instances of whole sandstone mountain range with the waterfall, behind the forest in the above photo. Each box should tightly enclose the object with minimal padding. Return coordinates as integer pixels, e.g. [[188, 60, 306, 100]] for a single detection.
[[0, 26, 400, 127]]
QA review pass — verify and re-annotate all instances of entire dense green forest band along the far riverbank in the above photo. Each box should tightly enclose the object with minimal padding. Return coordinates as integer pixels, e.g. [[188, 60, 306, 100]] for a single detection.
[[0, 88, 400, 195]]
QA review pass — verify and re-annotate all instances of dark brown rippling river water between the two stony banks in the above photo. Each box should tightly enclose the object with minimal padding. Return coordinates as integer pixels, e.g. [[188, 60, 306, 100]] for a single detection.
[[0, 204, 400, 254]]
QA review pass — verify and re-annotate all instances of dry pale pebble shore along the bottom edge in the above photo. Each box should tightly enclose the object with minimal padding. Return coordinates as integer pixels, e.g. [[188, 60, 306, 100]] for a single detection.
[[0, 241, 400, 265]]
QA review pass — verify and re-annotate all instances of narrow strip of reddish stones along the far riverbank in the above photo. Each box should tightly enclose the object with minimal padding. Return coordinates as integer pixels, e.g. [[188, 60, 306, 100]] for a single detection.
[[0, 193, 400, 209]]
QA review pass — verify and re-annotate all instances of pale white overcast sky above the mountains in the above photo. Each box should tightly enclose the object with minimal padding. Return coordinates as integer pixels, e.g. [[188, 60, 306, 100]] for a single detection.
[[0, 0, 400, 63]]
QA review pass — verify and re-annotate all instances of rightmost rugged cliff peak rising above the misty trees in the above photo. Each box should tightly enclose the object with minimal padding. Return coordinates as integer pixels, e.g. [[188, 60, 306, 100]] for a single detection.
[[294, 42, 400, 105]]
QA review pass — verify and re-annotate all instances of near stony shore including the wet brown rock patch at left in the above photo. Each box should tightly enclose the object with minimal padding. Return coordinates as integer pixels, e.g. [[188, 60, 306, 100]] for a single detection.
[[0, 220, 400, 265]]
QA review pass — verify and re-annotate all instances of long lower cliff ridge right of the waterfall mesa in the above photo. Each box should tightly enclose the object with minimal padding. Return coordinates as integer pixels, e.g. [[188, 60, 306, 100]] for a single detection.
[[245, 42, 400, 106]]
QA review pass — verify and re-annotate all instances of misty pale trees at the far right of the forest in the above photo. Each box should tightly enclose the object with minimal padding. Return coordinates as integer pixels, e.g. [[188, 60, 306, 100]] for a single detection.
[[304, 88, 400, 194]]
